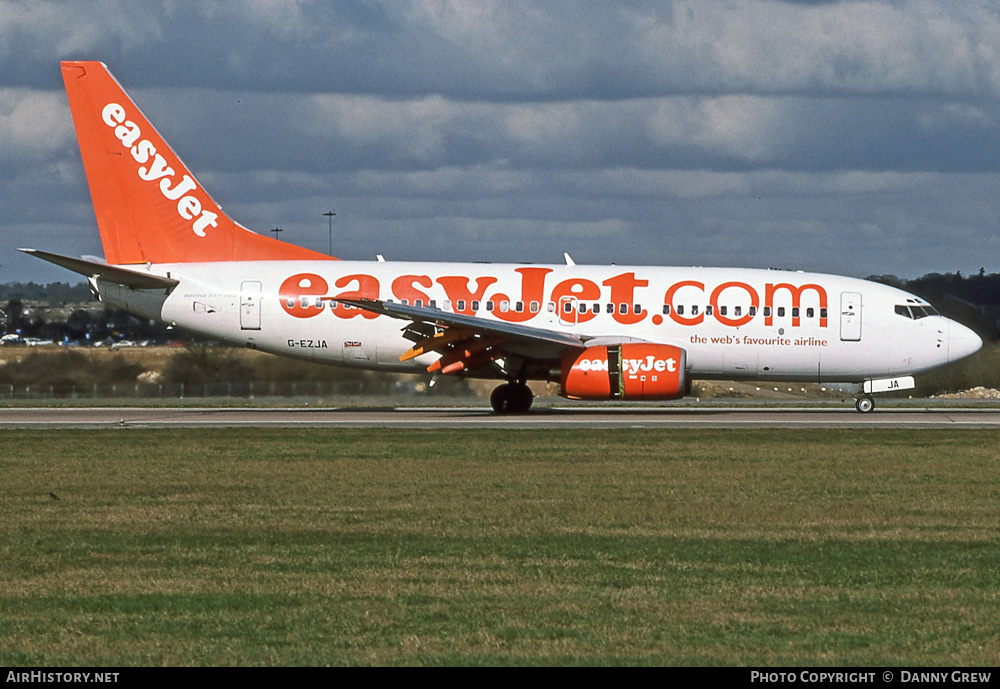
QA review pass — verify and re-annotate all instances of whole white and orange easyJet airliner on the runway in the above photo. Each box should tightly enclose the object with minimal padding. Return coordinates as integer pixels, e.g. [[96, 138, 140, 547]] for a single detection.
[[24, 62, 982, 412]]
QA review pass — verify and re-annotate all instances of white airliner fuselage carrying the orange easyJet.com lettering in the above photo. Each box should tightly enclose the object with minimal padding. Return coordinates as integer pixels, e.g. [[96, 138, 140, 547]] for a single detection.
[[100, 260, 981, 382]]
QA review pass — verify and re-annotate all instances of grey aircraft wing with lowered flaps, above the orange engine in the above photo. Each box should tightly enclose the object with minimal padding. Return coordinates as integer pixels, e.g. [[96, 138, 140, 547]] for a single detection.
[[336, 299, 590, 373]]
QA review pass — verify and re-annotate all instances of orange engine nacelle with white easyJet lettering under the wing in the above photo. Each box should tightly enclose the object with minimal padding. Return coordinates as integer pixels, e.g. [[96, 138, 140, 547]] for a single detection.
[[562, 343, 689, 400]]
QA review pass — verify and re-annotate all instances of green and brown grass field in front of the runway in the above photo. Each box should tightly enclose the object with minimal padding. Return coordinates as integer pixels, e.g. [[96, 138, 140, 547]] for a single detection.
[[0, 429, 1000, 666]]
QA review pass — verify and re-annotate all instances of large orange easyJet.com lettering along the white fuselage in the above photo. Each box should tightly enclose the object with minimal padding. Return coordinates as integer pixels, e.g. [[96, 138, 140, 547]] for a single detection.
[[279, 266, 828, 330]]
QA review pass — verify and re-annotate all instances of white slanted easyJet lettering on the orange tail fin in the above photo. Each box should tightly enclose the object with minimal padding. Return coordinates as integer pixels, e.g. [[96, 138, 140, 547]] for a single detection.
[[101, 103, 219, 237]]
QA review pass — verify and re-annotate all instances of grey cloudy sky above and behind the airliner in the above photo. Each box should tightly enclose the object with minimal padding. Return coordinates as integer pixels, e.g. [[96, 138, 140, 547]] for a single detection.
[[0, 0, 1000, 281]]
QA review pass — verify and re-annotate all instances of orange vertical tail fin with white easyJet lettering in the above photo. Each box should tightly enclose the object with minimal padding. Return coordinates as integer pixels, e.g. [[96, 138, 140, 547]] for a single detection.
[[62, 62, 333, 265]]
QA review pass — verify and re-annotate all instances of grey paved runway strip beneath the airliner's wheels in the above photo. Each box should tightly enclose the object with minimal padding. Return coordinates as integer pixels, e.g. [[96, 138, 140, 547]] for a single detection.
[[0, 406, 1000, 428]]
